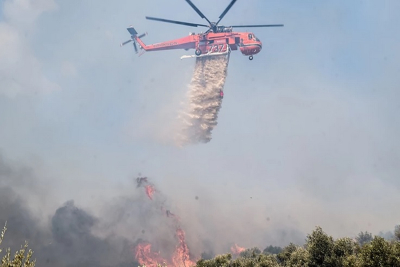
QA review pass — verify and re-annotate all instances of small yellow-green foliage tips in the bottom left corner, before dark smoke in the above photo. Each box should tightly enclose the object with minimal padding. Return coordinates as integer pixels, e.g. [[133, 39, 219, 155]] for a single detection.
[[0, 223, 36, 267]]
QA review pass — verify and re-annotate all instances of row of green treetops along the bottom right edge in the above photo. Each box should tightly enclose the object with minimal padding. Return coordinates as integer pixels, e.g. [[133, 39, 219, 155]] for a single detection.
[[196, 226, 400, 267]]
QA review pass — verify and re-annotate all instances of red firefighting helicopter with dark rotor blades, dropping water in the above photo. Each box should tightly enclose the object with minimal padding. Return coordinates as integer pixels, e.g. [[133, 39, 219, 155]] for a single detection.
[[121, 0, 283, 60]]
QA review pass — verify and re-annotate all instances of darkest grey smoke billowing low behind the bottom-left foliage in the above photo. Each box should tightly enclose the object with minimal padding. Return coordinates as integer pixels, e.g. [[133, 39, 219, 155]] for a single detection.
[[0, 192, 138, 267]]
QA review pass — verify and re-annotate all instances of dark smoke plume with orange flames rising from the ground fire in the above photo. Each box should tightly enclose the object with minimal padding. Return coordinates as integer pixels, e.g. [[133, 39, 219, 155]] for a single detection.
[[0, 154, 310, 267]]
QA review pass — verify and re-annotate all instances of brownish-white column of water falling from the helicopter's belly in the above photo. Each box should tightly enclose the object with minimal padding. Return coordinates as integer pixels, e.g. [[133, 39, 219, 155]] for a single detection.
[[178, 54, 229, 145]]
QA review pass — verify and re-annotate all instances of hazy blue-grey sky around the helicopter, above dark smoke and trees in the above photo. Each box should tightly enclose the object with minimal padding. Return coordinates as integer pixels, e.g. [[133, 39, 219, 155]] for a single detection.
[[0, 0, 400, 258]]
